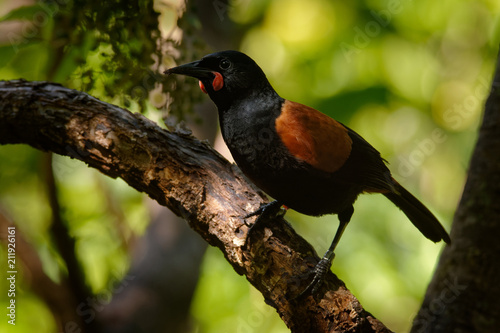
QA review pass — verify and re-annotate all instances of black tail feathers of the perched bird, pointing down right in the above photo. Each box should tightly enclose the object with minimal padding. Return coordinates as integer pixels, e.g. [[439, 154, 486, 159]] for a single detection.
[[383, 181, 450, 244]]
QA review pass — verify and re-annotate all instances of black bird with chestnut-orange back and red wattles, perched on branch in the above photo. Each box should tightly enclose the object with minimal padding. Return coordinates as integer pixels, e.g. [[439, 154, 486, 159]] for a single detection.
[[164, 50, 451, 295]]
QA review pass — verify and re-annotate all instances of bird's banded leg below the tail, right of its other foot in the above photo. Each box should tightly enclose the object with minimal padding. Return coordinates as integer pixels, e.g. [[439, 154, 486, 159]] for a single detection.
[[298, 206, 354, 297]]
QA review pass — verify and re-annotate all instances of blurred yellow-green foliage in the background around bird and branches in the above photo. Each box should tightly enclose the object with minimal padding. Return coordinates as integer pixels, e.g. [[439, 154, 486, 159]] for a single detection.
[[0, 0, 500, 333]]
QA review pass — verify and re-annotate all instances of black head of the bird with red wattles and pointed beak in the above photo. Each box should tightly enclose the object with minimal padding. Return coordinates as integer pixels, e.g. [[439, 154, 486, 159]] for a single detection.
[[165, 51, 274, 108]]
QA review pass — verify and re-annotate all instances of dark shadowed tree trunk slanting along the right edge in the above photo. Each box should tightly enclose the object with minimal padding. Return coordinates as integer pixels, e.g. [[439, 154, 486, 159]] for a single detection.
[[412, 49, 500, 333]]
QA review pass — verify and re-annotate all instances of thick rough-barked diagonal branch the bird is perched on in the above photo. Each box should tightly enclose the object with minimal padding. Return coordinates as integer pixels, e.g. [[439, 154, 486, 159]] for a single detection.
[[0, 81, 389, 332]]
